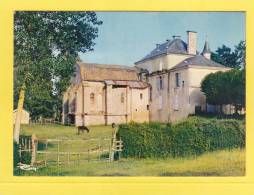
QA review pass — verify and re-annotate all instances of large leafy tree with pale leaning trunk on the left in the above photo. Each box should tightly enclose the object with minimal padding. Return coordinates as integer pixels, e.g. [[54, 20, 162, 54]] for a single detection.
[[14, 11, 102, 142]]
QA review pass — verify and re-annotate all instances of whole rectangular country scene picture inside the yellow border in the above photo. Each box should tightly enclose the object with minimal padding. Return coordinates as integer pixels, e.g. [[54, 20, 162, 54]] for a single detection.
[[11, 10, 246, 177]]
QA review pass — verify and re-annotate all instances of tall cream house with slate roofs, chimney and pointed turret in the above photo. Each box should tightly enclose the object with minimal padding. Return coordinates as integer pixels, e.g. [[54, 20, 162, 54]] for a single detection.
[[135, 31, 230, 122]]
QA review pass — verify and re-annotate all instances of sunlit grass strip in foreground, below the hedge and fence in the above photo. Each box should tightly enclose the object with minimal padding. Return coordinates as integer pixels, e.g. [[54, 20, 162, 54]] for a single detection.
[[16, 149, 245, 176]]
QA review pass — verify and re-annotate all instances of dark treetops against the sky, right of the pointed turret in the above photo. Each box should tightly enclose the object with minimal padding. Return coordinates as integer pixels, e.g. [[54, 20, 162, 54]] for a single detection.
[[211, 41, 246, 69]]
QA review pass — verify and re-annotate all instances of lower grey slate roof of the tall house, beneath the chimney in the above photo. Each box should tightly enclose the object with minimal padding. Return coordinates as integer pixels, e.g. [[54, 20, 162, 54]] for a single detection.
[[171, 55, 225, 69]]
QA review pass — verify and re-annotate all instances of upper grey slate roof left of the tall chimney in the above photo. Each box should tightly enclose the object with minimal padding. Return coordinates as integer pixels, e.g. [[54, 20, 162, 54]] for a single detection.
[[135, 38, 188, 64]]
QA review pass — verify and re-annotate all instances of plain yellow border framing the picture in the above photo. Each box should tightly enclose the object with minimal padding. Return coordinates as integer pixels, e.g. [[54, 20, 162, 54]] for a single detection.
[[0, 0, 254, 194]]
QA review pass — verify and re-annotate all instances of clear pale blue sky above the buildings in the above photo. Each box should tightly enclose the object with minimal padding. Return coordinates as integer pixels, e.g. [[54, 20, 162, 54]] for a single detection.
[[80, 12, 245, 66]]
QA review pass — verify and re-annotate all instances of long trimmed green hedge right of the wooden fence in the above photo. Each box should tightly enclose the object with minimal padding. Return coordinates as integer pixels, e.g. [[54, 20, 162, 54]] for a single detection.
[[117, 117, 245, 158]]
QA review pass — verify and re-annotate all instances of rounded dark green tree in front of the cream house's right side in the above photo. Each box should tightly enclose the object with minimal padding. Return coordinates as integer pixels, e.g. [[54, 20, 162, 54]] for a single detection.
[[201, 69, 245, 112]]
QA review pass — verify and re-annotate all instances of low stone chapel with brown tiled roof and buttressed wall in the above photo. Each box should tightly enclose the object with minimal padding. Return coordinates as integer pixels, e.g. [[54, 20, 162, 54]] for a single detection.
[[62, 62, 149, 126]]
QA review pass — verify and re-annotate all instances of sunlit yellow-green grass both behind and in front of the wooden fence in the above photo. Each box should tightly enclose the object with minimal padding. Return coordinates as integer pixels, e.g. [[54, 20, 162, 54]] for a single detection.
[[14, 122, 245, 176]]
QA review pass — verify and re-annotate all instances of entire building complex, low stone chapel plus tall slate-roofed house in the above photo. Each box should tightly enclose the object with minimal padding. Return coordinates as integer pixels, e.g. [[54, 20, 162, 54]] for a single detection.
[[62, 31, 230, 126]]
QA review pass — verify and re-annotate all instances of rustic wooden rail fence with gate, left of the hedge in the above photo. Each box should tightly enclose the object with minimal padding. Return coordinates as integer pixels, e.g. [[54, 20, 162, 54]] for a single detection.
[[19, 134, 123, 166]]
